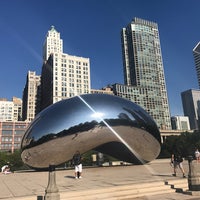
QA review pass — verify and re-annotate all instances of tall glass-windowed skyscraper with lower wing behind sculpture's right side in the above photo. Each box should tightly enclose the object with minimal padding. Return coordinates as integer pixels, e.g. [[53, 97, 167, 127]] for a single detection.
[[118, 18, 171, 129]]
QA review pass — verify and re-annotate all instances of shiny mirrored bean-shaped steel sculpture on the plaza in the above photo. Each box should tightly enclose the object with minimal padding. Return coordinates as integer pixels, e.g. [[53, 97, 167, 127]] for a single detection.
[[21, 94, 161, 169]]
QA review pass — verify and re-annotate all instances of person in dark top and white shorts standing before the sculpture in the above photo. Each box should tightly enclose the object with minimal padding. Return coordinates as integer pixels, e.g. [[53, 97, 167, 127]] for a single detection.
[[72, 151, 82, 179]]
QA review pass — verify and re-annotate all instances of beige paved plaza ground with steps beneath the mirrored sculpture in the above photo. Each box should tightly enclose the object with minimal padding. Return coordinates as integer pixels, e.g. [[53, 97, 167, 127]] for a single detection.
[[0, 159, 200, 200]]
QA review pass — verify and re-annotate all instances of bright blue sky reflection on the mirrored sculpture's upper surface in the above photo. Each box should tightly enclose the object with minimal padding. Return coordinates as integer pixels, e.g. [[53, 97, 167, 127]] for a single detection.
[[26, 96, 138, 140]]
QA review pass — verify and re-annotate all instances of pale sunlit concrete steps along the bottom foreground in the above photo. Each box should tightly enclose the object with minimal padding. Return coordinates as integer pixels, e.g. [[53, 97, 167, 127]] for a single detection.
[[60, 181, 174, 200]]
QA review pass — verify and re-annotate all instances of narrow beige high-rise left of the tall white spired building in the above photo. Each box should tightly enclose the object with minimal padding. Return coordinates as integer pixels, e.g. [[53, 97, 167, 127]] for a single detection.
[[22, 71, 41, 121]]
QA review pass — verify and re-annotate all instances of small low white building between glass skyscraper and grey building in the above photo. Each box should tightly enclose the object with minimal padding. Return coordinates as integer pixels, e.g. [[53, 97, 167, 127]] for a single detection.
[[171, 116, 190, 131]]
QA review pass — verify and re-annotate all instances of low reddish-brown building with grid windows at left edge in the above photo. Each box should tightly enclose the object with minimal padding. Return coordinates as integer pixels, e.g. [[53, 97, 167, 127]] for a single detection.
[[0, 121, 29, 152]]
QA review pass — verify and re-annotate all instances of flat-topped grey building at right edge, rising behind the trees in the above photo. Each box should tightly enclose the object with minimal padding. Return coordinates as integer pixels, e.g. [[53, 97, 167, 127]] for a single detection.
[[181, 89, 200, 130]]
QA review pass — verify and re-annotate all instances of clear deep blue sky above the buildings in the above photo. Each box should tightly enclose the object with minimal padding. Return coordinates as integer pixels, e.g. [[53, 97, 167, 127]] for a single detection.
[[0, 0, 200, 115]]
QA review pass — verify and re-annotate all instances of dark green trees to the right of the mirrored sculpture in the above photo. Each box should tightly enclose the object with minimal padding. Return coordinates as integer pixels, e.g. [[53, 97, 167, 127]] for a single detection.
[[159, 131, 200, 158]]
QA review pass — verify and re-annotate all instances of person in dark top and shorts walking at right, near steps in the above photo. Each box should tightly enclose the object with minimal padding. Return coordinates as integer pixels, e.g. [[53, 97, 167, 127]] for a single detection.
[[171, 153, 186, 178]]
